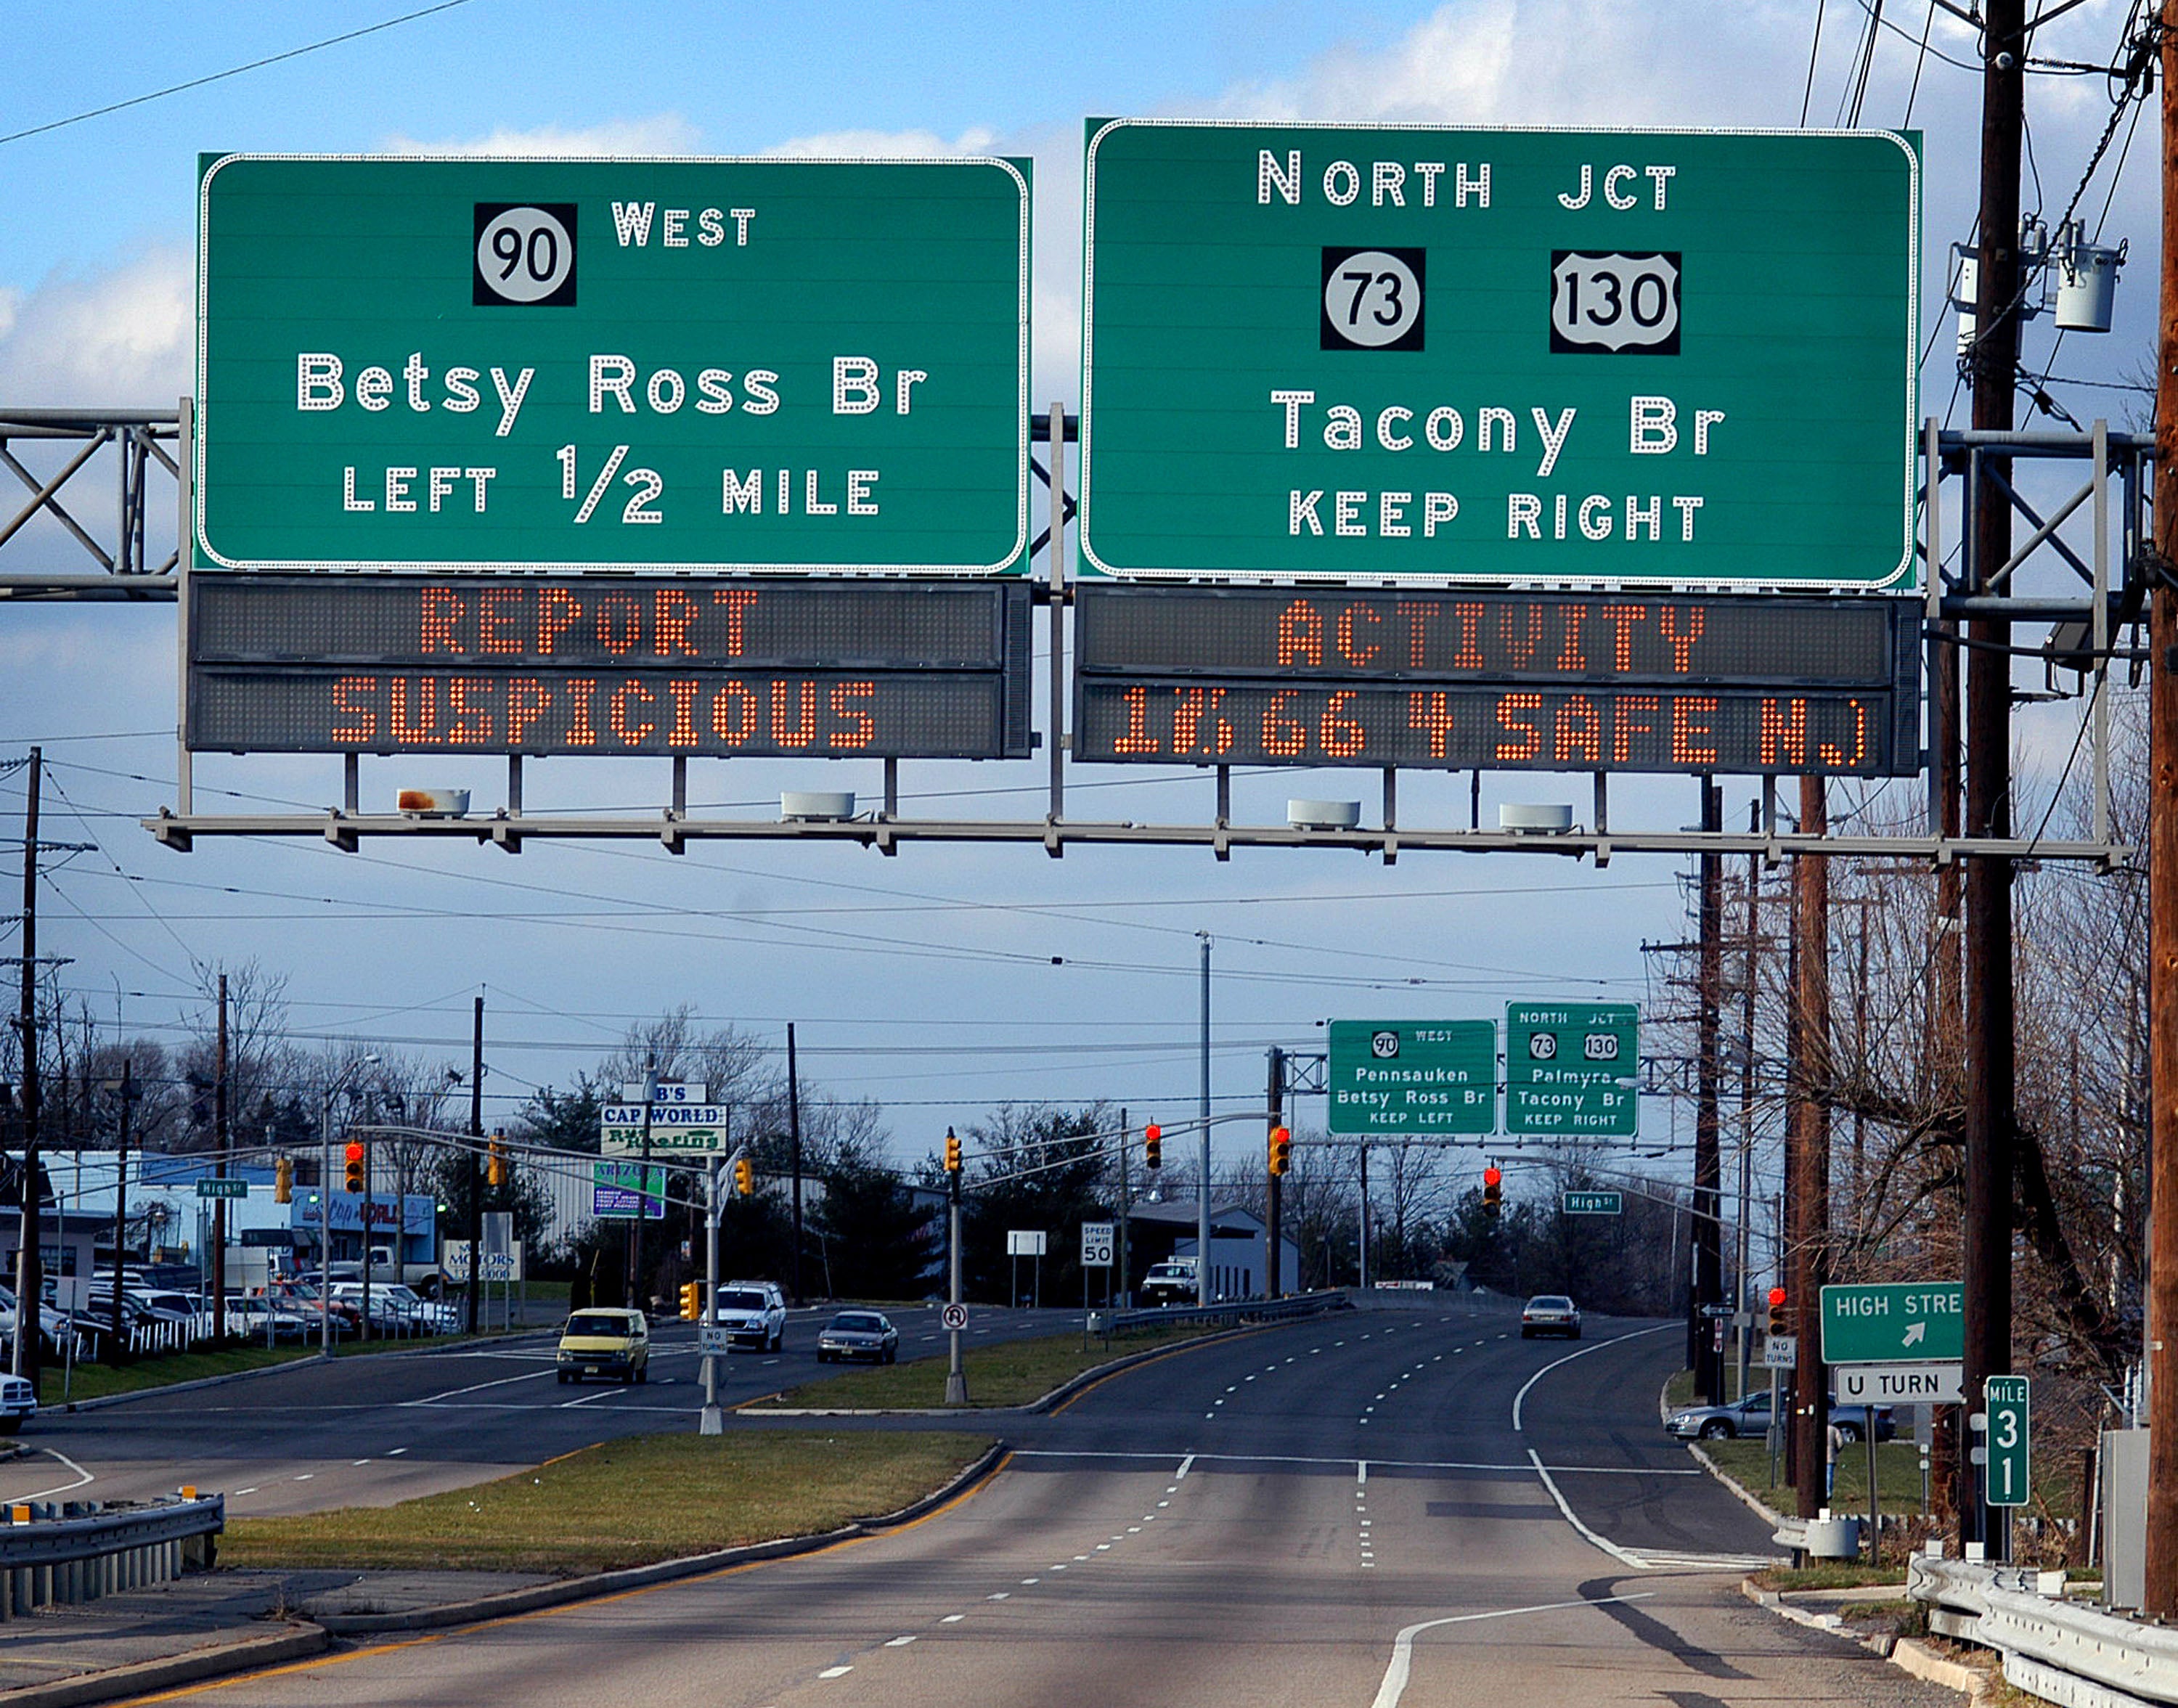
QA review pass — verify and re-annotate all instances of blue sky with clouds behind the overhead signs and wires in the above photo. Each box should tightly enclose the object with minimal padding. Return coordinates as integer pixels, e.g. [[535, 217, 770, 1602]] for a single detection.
[[0, 0, 2156, 1185]]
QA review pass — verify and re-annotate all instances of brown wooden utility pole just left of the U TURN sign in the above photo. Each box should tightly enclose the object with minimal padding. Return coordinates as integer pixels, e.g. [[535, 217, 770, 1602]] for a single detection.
[[1786, 777, 1830, 1519]]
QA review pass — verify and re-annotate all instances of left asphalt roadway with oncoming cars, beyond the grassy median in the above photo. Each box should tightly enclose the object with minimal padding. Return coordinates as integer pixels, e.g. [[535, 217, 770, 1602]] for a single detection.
[[0, 1305, 1080, 1519]]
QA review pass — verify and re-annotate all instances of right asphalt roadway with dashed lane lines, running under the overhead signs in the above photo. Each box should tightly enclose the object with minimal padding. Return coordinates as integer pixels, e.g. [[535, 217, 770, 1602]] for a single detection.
[[98, 1309, 1954, 1708]]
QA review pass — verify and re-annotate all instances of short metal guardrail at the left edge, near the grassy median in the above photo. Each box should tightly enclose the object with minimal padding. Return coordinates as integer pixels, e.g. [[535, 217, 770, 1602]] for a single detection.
[[0, 1495, 227, 1621]]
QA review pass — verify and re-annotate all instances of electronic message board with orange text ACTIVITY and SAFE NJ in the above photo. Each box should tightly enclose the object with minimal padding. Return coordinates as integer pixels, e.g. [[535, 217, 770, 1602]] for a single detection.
[[1074, 584, 1921, 775]]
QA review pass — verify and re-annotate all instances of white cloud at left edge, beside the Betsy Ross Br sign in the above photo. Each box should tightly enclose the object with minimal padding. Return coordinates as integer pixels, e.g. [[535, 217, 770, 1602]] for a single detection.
[[0, 246, 196, 409]]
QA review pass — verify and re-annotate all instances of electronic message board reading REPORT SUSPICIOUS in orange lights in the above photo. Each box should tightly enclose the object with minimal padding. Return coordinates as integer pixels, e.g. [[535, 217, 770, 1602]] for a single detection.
[[183, 571, 1030, 758]]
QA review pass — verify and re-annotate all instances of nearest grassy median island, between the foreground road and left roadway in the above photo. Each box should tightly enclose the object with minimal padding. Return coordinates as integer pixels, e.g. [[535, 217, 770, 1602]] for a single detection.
[[220, 1429, 991, 1577]]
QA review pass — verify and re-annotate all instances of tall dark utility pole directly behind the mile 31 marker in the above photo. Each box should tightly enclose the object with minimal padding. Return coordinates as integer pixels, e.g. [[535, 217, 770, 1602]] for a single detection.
[[1958, 0, 2028, 1558]]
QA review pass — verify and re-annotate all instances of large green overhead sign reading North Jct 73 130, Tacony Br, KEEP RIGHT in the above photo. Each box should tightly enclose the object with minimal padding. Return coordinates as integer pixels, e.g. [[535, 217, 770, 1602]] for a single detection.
[[1080, 120, 1921, 588]]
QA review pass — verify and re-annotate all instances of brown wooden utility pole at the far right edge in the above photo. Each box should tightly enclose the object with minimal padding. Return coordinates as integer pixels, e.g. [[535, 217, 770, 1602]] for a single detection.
[[2141, 0, 2178, 1619]]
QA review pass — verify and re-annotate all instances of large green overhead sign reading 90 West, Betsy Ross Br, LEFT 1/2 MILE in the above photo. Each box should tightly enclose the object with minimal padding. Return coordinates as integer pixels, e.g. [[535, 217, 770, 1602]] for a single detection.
[[194, 155, 1028, 573]]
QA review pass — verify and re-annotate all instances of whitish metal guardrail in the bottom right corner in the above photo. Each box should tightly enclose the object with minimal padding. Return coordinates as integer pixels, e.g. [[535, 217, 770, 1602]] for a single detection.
[[1906, 1558, 2178, 1708]]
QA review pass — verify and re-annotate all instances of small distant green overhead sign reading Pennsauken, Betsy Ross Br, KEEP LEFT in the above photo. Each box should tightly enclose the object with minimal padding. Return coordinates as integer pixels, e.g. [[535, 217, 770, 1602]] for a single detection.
[[1326, 1020, 1496, 1137]]
